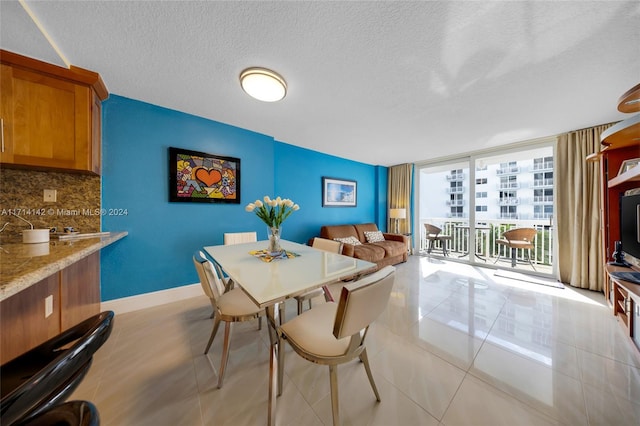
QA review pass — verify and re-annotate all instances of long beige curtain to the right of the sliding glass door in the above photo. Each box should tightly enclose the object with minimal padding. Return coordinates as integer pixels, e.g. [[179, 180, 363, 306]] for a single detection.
[[555, 124, 611, 291]]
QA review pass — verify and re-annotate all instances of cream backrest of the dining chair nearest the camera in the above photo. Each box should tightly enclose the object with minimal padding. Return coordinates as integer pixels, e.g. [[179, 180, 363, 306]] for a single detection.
[[333, 266, 396, 339]]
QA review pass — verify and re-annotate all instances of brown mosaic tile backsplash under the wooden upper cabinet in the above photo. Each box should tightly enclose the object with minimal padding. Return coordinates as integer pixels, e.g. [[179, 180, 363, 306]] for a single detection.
[[0, 167, 101, 239]]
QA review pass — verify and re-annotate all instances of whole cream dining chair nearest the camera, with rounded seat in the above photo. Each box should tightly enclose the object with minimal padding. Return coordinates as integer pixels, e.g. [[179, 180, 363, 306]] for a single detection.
[[278, 266, 395, 426]]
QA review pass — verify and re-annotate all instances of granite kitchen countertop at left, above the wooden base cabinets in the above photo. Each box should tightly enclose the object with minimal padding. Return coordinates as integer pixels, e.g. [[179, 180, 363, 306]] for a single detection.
[[0, 232, 127, 301]]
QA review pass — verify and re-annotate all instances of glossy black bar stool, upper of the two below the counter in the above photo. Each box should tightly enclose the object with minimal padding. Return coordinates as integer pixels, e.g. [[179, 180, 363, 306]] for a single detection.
[[0, 311, 114, 426]]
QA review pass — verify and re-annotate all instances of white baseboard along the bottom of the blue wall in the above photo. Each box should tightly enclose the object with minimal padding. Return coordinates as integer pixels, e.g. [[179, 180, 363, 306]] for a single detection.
[[100, 283, 204, 314]]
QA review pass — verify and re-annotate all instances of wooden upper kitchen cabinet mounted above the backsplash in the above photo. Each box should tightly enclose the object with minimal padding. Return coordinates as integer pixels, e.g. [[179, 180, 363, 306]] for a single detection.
[[0, 50, 108, 174]]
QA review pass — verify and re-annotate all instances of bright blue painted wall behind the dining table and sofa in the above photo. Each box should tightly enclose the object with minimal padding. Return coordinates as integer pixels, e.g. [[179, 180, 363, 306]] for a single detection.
[[101, 95, 387, 301]]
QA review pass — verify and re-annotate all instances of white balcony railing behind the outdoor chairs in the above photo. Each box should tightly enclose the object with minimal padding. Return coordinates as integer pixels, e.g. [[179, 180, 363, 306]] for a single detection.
[[417, 218, 554, 270]]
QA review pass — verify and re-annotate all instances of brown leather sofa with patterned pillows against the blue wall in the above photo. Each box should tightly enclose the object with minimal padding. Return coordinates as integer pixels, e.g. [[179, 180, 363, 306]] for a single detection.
[[320, 223, 409, 269]]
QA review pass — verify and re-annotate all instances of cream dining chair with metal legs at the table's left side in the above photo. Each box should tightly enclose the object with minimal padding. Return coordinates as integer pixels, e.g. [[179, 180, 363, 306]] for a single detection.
[[193, 251, 265, 389]]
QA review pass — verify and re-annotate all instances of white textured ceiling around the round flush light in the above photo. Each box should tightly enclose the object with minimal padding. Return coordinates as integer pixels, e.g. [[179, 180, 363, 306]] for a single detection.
[[0, 0, 640, 166]]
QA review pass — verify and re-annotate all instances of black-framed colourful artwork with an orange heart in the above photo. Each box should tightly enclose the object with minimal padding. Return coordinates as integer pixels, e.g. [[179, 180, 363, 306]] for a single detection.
[[169, 148, 240, 204]]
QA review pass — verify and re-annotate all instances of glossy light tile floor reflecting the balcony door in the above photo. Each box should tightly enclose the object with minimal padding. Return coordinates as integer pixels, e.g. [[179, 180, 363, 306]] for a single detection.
[[72, 256, 640, 426]]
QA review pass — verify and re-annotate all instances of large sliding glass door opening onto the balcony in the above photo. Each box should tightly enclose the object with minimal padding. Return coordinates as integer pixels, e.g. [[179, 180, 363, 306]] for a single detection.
[[416, 141, 554, 274]]
